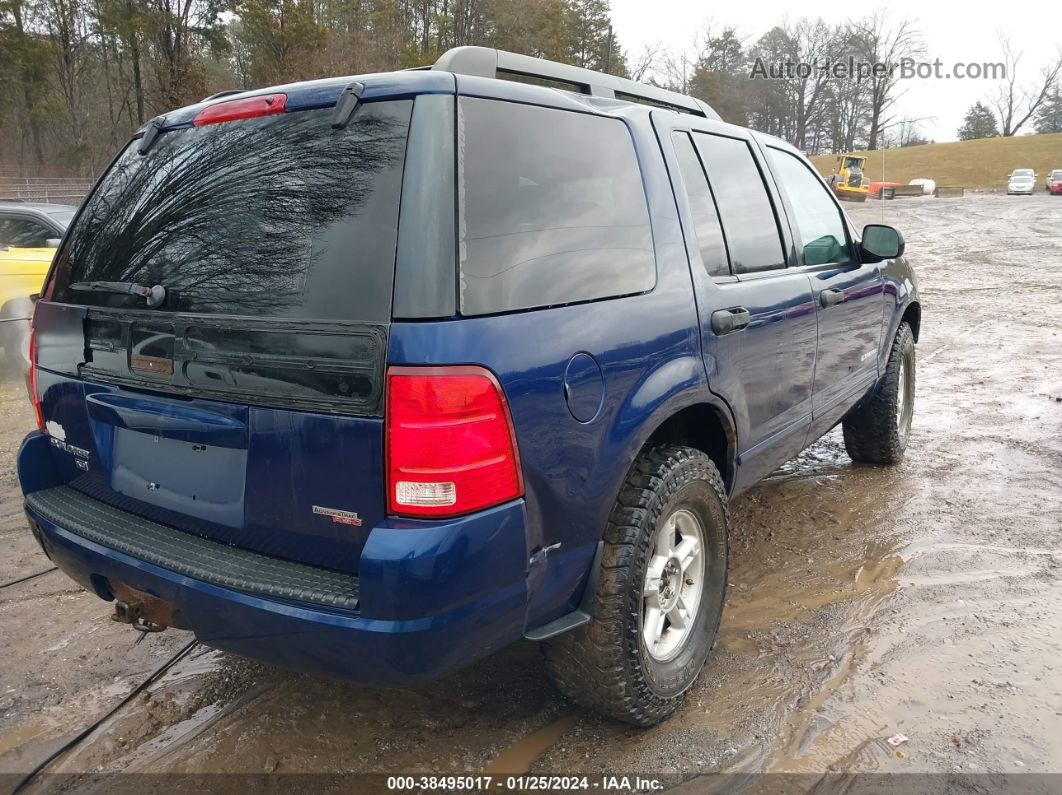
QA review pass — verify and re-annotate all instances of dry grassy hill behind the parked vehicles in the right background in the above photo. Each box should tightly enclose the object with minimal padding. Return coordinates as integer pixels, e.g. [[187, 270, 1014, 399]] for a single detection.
[[811, 133, 1062, 190]]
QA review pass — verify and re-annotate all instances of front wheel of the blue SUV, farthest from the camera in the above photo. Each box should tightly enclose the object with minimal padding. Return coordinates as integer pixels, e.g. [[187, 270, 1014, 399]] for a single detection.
[[842, 323, 914, 464]]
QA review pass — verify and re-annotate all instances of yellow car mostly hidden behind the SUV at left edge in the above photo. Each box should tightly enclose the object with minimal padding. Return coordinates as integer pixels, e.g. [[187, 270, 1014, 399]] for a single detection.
[[0, 248, 55, 368]]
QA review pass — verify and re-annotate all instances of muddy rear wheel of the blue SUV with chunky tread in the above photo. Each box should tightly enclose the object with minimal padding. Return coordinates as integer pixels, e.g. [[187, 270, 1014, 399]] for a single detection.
[[543, 446, 730, 726]]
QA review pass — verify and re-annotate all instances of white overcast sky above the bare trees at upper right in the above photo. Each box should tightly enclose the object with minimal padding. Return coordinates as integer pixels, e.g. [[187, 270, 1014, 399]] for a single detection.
[[612, 0, 1062, 141]]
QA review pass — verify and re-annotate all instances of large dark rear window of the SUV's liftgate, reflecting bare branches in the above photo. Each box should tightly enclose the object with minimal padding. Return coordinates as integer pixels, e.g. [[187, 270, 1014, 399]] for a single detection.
[[56, 100, 412, 322]]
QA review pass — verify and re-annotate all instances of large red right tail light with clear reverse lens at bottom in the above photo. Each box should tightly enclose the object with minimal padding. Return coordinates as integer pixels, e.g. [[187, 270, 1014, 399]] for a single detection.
[[386, 366, 524, 517]]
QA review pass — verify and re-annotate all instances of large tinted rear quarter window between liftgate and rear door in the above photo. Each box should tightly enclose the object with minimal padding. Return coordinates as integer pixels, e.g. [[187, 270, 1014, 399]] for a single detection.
[[458, 99, 656, 314]]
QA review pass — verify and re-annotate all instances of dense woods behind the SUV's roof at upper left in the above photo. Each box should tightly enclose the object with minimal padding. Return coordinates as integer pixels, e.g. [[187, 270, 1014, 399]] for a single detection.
[[0, 0, 627, 170]]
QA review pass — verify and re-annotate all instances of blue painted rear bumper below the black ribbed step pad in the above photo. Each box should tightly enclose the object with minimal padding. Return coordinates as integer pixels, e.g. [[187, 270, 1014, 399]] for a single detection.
[[19, 434, 528, 684]]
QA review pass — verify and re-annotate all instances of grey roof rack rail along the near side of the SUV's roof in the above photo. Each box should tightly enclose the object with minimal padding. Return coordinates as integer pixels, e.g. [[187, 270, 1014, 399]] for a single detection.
[[431, 47, 721, 121]]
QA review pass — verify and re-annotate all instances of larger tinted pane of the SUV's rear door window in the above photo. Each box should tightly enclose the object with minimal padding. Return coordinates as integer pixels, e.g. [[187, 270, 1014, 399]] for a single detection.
[[693, 133, 785, 273]]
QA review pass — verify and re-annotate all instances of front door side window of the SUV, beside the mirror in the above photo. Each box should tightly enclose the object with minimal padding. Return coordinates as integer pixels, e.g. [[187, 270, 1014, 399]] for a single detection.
[[767, 146, 852, 265]]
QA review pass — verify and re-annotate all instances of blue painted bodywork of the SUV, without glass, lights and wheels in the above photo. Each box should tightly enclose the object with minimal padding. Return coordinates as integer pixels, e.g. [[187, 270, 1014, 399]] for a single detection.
[[18, 65, 918, 682]]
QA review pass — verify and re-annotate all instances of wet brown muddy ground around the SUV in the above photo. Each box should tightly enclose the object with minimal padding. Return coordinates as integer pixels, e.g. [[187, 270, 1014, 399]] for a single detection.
[[0, 195, 1062, 792]]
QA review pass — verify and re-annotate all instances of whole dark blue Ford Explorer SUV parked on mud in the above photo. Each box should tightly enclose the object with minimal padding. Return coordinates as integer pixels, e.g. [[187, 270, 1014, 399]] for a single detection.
[[18, 48, 921, 725]]
